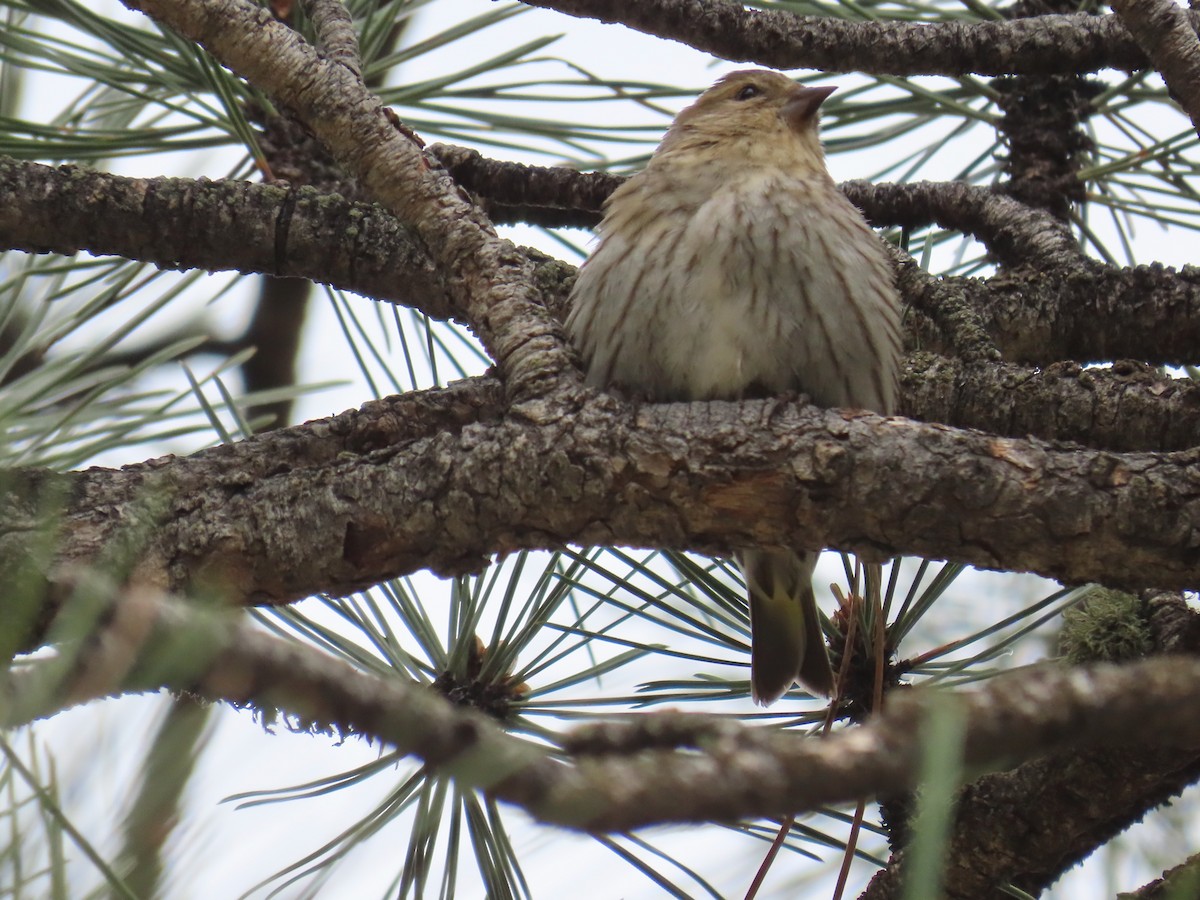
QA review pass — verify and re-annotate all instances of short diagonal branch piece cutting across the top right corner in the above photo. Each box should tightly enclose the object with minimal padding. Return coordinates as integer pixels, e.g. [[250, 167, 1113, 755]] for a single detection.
[[1112, 0, 1200, 132]]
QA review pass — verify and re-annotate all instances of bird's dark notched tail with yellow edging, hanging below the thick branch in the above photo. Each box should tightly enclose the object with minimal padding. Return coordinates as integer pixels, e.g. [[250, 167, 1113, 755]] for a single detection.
[[738, 550, 833, 706]]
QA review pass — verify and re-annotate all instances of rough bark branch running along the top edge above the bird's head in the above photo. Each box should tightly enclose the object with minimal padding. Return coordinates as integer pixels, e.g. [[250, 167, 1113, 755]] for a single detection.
[[526, 0, 1166, 76]]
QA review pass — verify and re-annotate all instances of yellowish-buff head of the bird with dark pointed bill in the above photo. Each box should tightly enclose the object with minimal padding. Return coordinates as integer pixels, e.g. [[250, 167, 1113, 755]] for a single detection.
[[655, 68, 835, 172]]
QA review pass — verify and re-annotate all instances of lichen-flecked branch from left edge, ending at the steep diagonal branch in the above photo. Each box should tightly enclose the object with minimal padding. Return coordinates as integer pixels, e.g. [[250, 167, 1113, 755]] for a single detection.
[[0, 156, 461, 319]]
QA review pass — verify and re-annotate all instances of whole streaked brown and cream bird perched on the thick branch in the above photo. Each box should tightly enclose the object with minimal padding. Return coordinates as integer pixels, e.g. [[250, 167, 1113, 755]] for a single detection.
[[566, 70, 901, 706]]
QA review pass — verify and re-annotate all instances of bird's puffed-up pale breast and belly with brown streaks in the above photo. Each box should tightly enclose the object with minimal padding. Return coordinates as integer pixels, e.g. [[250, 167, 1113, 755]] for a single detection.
[[570, 174, 899, 412]]
